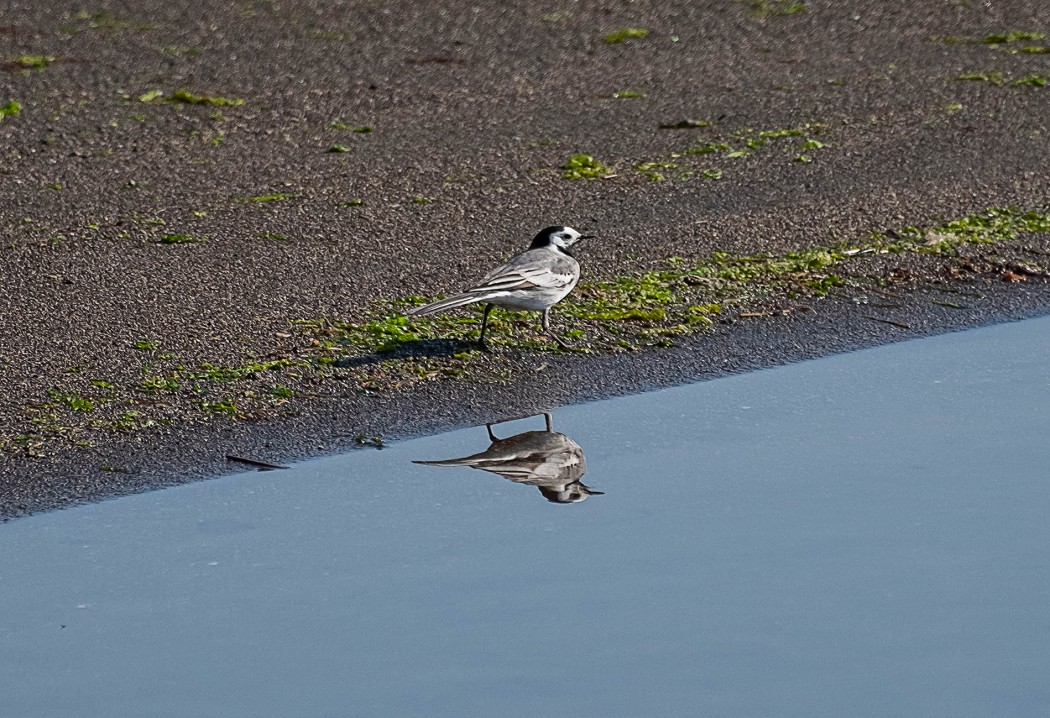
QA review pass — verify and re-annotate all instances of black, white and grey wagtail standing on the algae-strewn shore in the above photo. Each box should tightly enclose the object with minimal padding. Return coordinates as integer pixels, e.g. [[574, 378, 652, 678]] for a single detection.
[[406, 222, 590, 352]]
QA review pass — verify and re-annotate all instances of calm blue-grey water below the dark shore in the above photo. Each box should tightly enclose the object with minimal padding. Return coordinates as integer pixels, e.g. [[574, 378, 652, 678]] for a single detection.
[[0, 318, 1050, 718]]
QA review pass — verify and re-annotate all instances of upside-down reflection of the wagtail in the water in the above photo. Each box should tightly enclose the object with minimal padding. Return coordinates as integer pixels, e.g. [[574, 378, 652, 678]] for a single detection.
[[412, 414, 604, 504]]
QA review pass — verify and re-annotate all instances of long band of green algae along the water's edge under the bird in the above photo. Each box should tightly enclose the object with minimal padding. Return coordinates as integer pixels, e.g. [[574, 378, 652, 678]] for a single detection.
[[8, 207, 1050, 457]]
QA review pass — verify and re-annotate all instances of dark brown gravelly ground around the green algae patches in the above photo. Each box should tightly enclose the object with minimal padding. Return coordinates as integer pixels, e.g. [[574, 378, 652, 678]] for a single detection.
[[0, 0, 1050, 515]]
